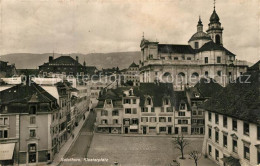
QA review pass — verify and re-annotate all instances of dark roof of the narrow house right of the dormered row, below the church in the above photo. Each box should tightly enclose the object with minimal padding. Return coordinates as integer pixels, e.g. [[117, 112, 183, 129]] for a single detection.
[[194, 78, 223, 98]]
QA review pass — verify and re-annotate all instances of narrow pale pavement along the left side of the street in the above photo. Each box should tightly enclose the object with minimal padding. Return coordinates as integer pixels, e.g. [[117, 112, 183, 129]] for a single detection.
[[50, 111, 89, 165]]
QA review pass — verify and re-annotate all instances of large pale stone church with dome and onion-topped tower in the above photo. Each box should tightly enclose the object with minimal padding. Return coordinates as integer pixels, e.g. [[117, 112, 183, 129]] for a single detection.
[[139, 5, 248, 90]]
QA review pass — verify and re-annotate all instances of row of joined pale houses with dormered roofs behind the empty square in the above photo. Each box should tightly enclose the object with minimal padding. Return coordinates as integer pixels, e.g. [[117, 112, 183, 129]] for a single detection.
[[95, 83, 191, 134]]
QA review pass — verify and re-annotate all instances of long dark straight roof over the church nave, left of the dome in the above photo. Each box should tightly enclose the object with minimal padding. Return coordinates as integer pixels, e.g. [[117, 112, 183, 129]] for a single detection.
[[158, 44, 195, 54]]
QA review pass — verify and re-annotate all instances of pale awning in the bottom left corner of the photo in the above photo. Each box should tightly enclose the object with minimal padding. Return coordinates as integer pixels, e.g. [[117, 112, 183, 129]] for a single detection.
[[0, 143, 15, 160]]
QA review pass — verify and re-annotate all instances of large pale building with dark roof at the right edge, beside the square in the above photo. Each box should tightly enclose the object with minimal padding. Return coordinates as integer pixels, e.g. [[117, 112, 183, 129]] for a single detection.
[[202, 65, 260, 166]]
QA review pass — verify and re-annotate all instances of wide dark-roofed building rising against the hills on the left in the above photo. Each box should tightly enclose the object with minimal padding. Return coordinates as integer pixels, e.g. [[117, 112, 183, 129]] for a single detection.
[[39, 56, 97, 77]]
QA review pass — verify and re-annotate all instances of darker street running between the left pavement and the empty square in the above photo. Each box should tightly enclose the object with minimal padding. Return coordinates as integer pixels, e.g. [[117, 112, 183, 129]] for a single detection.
[[60, 111, 96, 165]]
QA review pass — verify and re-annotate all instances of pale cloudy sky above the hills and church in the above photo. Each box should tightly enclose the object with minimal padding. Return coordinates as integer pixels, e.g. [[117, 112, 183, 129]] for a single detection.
[[0, 0, 260, 62]]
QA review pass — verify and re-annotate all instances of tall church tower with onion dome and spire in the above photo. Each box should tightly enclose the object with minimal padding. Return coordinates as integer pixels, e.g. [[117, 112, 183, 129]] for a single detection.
[[207, 0, 223, 46]]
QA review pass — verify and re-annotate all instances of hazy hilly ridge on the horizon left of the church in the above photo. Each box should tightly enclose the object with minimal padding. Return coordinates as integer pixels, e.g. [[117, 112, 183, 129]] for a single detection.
[[0, 51, 140, 69]]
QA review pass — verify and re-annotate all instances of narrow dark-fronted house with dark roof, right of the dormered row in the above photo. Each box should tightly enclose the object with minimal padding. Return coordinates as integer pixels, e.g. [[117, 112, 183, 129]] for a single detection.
[[185, 78, 223, 135]]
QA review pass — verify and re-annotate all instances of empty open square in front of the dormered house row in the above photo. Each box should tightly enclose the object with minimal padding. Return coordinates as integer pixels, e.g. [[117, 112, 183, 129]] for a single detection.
[[86, 134, 203, 166]]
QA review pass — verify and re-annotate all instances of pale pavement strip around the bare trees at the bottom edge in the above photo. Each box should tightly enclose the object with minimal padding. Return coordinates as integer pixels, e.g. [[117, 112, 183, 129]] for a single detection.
[[176, 155, 218, 166]]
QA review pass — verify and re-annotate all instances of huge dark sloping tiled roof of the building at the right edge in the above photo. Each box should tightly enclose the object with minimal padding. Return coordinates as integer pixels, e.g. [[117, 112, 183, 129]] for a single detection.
[[204, 70, 260, 124]]
